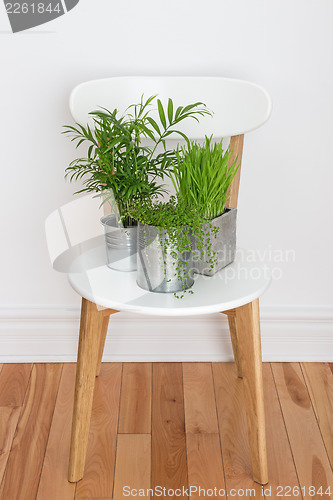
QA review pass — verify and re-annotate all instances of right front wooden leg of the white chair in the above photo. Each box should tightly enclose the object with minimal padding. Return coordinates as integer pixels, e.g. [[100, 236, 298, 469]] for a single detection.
[[235, 299, 268, 484]]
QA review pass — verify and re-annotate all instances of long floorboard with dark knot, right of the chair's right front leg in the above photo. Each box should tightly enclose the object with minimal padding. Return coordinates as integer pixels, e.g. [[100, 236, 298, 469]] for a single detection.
[[272, 363, 333, 499]]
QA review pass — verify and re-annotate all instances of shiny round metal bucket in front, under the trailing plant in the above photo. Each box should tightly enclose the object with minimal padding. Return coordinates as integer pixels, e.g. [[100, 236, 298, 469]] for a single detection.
[[136, 222, 194, 293]]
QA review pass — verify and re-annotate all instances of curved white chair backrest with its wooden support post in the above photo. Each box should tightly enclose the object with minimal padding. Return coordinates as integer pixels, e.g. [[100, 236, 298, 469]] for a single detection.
[[70, 77, 272, 207]]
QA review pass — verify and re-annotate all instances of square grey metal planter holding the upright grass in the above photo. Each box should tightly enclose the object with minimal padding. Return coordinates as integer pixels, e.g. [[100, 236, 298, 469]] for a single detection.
[[193, 208, 237, 276]]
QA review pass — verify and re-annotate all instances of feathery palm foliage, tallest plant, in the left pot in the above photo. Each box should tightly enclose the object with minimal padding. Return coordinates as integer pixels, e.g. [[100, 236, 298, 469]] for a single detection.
[[63, 96, 211, 227]]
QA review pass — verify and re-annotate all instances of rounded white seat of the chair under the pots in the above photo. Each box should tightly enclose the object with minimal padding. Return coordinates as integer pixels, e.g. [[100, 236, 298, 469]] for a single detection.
[[68, 245, 271, 316]]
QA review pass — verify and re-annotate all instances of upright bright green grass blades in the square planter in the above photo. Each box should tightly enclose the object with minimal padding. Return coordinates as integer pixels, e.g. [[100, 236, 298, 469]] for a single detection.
[[171, 137, 238, 219]]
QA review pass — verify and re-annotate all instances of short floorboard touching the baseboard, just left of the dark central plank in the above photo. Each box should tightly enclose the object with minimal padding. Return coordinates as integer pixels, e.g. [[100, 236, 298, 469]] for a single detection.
[[119, 363, 152, 434]]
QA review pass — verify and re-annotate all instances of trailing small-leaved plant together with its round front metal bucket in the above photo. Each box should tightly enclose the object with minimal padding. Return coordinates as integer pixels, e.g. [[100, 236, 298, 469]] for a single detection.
[[126, 196, 215, 298]]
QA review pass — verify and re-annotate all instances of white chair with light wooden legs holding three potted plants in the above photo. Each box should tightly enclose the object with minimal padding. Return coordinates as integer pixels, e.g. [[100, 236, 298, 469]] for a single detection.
[[48, 77, 271, 484]]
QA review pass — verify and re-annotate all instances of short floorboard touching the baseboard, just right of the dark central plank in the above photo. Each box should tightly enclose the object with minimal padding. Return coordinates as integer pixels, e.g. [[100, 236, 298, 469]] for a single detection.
[[183, 363, 219, 434]]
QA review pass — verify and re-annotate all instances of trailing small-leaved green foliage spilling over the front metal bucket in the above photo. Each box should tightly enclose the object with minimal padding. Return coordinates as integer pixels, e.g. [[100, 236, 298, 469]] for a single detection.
[[129, 196, 217, 298]]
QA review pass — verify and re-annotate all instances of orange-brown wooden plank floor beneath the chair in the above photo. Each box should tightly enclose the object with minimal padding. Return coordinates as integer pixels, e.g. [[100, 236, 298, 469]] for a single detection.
[[0, 363, 333, 500]]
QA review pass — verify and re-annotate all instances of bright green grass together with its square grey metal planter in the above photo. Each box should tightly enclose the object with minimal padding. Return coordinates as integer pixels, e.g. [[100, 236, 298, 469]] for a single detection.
[[171, 137, 238, 276]]
